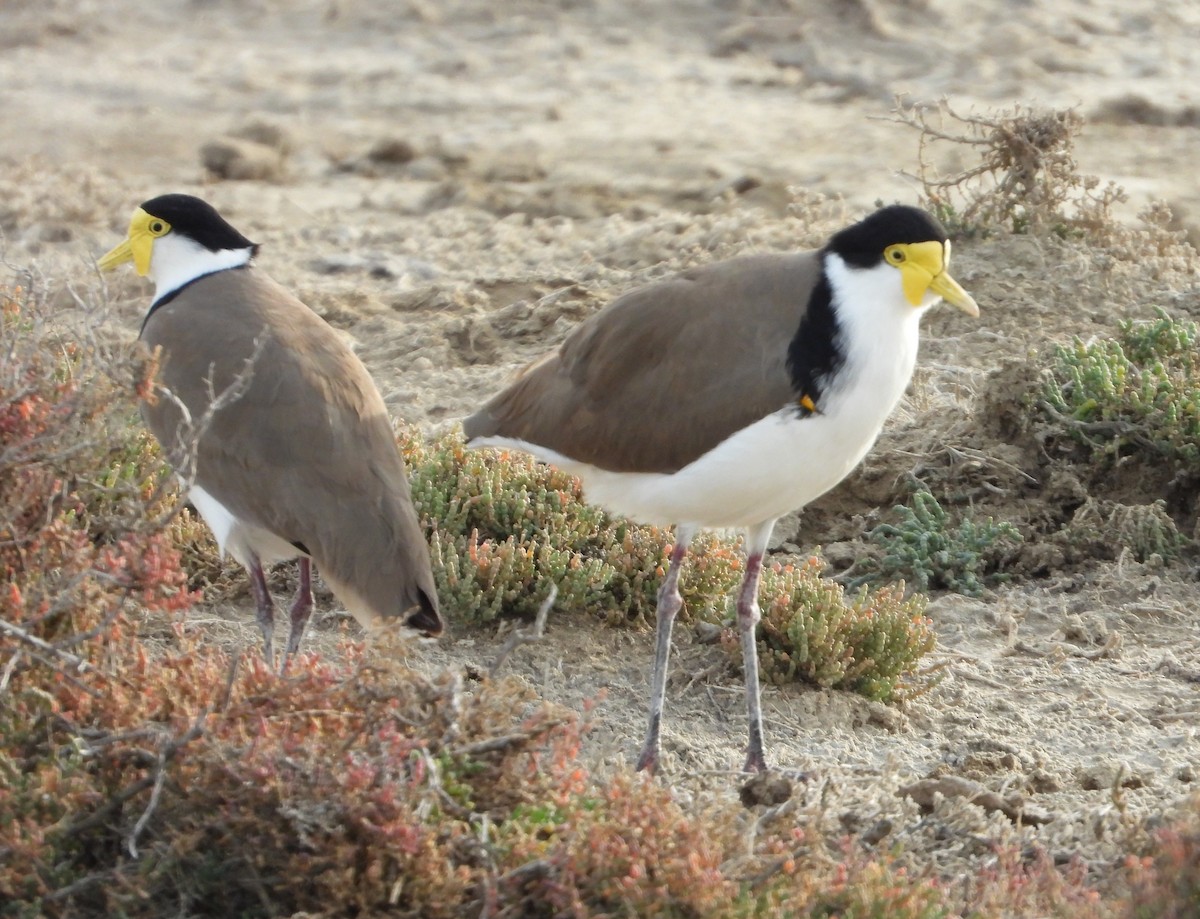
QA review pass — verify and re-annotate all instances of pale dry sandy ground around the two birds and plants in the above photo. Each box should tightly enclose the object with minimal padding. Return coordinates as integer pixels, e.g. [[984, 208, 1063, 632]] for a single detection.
[[7, 0, 1200, 871]]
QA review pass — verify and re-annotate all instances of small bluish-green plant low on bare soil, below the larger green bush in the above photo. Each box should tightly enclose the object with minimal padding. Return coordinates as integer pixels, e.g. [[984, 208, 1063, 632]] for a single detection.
[[854, 488, 1021, 596]]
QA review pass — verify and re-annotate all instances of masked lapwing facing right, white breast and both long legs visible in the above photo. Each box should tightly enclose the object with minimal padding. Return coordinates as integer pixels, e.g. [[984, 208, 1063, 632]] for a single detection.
[[463, 205, 979, 771]]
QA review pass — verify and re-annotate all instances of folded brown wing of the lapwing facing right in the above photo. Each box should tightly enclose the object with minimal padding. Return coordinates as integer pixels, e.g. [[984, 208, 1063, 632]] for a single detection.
[[463, 252, 820, 473]]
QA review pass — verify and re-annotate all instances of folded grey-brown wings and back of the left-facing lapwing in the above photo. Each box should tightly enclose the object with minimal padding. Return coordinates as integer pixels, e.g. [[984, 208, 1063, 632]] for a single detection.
[[142, 268, 438, 617]]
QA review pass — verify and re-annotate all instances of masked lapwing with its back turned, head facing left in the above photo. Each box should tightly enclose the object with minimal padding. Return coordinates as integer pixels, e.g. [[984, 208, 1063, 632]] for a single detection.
[[100, 194, 442, 662]]
